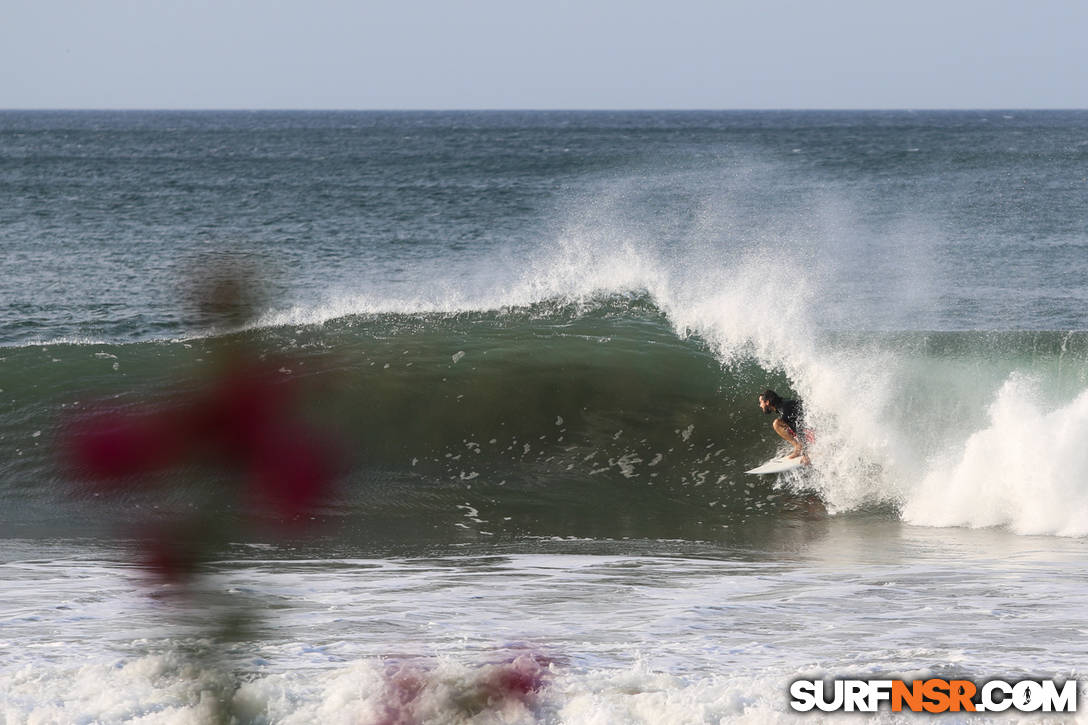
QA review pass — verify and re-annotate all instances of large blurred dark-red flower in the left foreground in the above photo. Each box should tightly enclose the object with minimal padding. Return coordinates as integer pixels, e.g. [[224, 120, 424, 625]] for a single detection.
[[62, 357, 343, 582]]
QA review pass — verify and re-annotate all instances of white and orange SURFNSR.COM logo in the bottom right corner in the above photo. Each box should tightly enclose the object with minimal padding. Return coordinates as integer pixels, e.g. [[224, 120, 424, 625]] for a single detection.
[[790, 678, 1077, 713]]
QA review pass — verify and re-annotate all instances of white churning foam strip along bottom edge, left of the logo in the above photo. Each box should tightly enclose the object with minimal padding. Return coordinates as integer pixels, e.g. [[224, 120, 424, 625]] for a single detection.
[[2, 655, 909, 725]]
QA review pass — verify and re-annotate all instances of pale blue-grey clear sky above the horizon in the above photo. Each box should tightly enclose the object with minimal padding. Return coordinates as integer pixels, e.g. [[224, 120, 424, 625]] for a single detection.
[[0, 0, 1088, 109]]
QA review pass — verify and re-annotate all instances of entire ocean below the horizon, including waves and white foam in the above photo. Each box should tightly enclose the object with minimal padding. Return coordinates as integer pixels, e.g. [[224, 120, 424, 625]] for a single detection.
[[0, 111, 1088, 725]]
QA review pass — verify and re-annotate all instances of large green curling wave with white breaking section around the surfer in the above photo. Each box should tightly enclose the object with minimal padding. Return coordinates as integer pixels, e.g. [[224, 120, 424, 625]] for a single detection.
[[6, 293, 1088, 539]]
